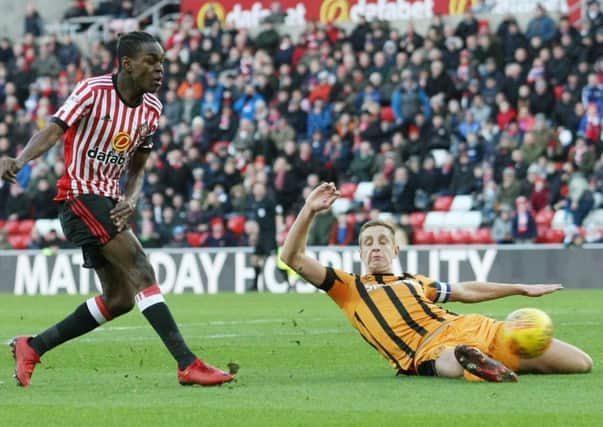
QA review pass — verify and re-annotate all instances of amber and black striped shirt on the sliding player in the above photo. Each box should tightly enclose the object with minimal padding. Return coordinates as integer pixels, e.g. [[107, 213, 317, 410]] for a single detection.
[[319, 267, 458, 372]]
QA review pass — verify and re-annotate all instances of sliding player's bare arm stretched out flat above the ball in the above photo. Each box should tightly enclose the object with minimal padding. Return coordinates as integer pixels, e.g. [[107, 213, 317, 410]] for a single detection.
[[449, 282, 563, 303]]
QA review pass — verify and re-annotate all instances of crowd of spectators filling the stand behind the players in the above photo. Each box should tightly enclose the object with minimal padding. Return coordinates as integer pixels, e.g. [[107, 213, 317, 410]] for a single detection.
[[0, 1, 603, 251]]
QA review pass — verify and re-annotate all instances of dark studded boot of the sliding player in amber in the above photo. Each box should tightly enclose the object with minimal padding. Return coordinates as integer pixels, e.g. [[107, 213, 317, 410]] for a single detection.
[[454, 345, 519, 383]]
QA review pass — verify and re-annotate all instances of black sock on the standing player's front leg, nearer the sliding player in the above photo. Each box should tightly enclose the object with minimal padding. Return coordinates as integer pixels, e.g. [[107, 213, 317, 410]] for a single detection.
[[142, 302, 197, 369]]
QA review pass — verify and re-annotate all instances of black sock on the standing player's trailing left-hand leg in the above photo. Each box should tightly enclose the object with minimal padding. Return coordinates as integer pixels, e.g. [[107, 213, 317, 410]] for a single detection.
[[29, 303, 100, 356]]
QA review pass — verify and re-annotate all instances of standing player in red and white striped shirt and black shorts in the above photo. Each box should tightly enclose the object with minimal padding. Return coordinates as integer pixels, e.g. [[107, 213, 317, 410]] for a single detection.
[[0, 31, 234, 387]]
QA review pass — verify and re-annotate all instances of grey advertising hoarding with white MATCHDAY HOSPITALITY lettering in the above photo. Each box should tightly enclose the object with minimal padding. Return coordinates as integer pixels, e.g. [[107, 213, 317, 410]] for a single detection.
[[0, 246, 603, 295]]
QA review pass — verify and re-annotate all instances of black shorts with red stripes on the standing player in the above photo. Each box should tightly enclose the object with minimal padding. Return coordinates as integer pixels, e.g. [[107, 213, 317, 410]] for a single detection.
[[59, 194, 119, 268]]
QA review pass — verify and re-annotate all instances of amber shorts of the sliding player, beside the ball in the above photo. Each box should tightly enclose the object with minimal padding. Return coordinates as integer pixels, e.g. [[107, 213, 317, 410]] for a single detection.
[[415, 314, 519, 372]]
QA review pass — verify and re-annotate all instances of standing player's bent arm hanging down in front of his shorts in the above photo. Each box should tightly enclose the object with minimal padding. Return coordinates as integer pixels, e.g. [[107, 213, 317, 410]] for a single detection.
[[111, 150, 151, 230]]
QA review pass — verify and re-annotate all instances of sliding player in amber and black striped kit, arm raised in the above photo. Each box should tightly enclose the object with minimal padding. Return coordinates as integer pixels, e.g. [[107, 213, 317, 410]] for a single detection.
[[281, 183, 592, 382]]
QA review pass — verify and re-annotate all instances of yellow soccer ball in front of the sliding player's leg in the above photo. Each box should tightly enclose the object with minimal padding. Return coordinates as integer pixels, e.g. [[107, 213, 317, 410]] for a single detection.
[[504, 308, 553, 359]]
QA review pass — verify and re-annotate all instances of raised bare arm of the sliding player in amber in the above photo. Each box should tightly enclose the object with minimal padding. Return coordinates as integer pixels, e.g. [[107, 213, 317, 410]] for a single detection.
[[281, 183, 339, 286]]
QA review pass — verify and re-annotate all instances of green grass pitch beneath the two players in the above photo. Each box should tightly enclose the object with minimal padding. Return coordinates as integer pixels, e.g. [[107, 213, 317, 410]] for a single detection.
[[0, 290, 603, 427]]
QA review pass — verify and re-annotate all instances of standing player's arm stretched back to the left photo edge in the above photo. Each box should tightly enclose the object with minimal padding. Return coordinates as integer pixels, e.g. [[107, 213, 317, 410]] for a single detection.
[[0, 122, 65, 182]]
